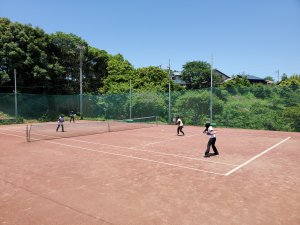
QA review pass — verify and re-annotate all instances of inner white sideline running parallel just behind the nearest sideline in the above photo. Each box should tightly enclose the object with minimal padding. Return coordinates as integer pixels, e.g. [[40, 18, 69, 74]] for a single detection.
[[68, 138, 237, 166]]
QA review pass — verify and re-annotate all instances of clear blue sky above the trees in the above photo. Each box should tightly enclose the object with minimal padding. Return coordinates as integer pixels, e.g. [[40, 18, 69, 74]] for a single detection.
[[0, 0, 300, 81]]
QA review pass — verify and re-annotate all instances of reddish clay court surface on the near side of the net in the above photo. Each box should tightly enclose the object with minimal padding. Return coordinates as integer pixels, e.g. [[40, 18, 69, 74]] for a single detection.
[[0, 125, 300, 225]]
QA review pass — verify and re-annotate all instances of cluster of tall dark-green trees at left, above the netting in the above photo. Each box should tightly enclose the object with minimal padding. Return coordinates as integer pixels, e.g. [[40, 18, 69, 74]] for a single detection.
[[0, 18, 110, 94]]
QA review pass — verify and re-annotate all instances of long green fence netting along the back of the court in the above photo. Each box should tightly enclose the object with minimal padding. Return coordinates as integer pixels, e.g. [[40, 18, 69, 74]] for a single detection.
[[0, 85, 300, 131]]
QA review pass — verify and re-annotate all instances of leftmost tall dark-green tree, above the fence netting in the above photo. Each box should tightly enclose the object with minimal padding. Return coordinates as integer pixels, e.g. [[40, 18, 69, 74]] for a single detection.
[[0, 18, 51, 93]]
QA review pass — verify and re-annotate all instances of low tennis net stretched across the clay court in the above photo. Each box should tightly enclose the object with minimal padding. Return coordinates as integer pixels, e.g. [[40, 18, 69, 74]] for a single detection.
[[26, 116, 157, 142]]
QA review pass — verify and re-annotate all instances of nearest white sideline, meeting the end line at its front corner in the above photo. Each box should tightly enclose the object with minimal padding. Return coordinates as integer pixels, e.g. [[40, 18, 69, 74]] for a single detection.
[[45, 141, 224, 176]]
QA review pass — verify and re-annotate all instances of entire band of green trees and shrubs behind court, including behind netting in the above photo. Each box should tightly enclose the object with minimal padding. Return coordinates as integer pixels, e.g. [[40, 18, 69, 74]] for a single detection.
[[0, 18, 300, 131]]
